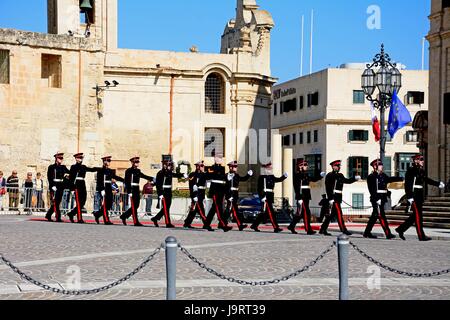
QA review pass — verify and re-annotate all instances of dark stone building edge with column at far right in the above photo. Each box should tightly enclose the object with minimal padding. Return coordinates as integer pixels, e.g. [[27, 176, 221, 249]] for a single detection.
[[426, 0, 450, 195]]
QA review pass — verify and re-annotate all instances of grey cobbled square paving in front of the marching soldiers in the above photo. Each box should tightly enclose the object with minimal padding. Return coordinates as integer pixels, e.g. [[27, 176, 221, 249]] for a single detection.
[[0, 216, 450, 300]]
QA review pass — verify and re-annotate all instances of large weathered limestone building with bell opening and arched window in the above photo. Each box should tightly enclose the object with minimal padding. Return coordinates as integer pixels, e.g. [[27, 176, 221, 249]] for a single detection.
[[0, 0, 276, 190]]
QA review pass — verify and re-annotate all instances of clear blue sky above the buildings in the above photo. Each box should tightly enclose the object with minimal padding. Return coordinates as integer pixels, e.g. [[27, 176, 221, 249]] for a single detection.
[[0, 0, 431, 81]]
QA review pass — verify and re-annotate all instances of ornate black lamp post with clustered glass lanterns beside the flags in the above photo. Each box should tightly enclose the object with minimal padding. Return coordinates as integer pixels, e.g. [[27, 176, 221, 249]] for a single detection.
[[361, 44, 402, 163]]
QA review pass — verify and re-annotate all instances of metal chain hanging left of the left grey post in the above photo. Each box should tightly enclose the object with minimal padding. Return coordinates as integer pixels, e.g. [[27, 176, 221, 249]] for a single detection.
[[0, 246, 162, 296]]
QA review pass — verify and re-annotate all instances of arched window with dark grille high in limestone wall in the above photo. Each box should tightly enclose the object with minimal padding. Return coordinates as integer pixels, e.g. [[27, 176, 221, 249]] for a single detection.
[[205, 73, 225, 113]]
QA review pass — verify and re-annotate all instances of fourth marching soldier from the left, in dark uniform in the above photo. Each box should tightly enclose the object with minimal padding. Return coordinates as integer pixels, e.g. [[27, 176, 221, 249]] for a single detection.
[[120, 157, 154, 227]]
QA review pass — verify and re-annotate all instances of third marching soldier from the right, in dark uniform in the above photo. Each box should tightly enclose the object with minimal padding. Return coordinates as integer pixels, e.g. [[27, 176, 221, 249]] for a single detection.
[[319, 160, 361, 236]]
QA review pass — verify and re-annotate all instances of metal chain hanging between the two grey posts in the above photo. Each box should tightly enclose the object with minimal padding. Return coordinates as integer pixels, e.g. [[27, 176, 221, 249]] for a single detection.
[[179, 242, 336, 286]]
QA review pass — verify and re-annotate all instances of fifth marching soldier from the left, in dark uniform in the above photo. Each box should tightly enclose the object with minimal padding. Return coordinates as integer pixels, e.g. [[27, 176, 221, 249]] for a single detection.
[[151, 159, 188, 228]]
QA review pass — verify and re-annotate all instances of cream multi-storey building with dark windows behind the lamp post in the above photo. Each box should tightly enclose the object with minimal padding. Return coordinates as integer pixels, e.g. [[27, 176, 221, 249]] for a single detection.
[[272, 64, 428, 211]]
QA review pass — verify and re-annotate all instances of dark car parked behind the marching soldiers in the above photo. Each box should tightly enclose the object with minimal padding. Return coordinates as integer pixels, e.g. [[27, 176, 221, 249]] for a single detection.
[[233, 196, 292, 223]]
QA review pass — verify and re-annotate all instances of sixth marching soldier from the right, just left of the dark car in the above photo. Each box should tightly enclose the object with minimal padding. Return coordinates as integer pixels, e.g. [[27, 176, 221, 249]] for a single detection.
[[224, 161, 253, 231]]
